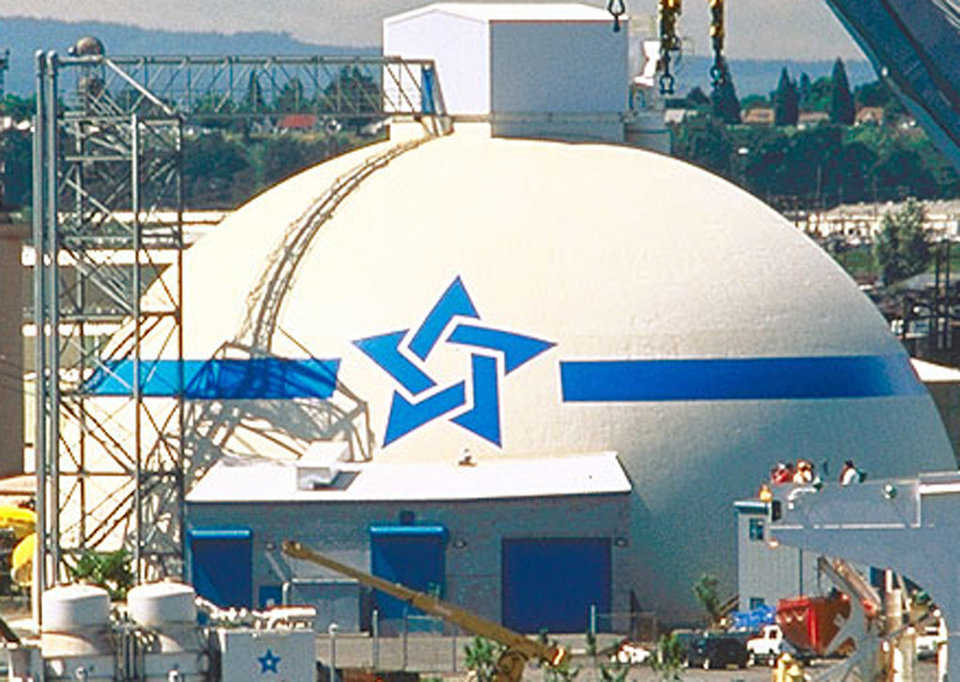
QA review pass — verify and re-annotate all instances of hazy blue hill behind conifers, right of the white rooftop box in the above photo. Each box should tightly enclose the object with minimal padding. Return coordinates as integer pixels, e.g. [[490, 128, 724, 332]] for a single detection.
[[656, 57, 877, 99]]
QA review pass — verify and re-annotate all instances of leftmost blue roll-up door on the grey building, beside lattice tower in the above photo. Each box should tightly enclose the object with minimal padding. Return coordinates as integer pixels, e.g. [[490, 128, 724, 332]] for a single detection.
[[187, 528, 253, 608]]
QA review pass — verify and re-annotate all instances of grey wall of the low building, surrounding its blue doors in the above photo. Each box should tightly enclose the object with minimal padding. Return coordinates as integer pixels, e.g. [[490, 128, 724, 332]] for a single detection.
[[188, 488, 636, 621]]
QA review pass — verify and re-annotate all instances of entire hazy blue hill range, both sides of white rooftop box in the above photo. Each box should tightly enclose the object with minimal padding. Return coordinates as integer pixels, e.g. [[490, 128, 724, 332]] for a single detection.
[[0, 17, 876, 97]]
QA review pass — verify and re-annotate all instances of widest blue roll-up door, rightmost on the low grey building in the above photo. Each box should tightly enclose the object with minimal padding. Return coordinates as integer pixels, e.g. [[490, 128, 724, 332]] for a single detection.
[[502, 538, 611, 633]]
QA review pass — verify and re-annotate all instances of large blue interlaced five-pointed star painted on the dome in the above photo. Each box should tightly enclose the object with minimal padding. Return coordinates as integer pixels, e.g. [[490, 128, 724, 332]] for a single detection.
[[353, 277, 556, 447]]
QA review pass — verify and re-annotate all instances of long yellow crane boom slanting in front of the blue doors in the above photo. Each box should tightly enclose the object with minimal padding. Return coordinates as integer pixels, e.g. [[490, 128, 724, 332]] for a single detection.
[[283, 540, 568, 682]]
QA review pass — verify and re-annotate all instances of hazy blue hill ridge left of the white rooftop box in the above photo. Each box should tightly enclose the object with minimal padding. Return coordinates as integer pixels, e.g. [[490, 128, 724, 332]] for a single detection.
[[0, 17, 380, 95]]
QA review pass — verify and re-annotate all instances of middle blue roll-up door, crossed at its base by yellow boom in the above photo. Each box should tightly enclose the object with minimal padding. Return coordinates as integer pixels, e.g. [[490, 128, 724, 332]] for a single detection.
[[370, 525, 447, 619]]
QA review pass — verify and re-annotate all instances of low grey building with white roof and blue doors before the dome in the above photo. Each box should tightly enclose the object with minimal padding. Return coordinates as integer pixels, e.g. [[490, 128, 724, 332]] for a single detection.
[[187, 453, 630, 632]]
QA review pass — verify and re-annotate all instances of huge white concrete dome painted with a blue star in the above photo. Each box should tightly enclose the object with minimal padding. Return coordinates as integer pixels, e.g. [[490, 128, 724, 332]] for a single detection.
[[135, 127, 955, 616]]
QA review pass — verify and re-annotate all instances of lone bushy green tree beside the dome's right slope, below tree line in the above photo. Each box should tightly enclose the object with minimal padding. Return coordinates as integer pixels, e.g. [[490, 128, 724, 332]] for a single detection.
[[873, 198, 933, 284]]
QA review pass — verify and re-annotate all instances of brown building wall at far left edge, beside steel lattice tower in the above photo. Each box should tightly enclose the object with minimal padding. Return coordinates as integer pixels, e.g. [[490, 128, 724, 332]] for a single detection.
[[0, 215, 28, 477]]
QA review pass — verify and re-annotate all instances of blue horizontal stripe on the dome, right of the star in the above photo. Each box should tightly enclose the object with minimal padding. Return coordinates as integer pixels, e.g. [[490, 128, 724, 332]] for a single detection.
[[560, 355, 925, 402]]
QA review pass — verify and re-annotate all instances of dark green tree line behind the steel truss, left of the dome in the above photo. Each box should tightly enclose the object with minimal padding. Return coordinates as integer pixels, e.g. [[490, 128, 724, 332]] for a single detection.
[[0, 66, 379, 209]]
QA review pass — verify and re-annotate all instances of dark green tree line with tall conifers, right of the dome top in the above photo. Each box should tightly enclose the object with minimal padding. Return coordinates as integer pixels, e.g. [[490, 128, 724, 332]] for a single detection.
[[674, 60, 960, 208]]
